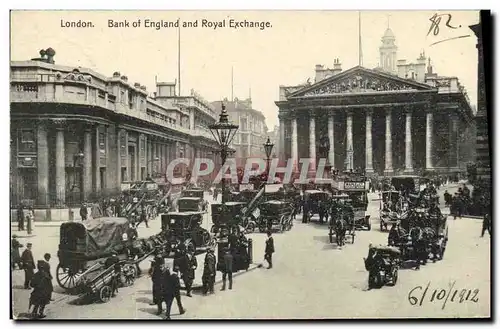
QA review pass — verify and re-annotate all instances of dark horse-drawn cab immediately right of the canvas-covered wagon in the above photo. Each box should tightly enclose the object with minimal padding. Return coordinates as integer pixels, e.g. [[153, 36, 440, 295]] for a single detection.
[[161, 211, 215, 255]]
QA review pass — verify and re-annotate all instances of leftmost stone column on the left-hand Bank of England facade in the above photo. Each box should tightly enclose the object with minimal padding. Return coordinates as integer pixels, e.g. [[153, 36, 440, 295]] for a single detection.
[[37, 122, 49, 206]]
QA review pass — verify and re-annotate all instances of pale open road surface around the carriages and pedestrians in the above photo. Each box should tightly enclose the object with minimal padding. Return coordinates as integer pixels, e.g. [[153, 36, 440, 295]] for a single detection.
[[13, 187, 491, 319]]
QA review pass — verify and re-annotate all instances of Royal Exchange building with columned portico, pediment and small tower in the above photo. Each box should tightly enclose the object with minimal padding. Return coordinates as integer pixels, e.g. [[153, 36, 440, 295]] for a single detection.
[[275, 28, 473, 175]]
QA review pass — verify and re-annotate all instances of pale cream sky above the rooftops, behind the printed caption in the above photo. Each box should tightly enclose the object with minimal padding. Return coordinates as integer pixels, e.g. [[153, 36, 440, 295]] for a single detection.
[[11, 11, 479, 130]]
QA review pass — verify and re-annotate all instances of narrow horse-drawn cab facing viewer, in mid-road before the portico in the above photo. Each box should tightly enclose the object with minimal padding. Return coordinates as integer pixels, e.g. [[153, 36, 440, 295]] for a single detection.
[[328, 194, 356, 247]]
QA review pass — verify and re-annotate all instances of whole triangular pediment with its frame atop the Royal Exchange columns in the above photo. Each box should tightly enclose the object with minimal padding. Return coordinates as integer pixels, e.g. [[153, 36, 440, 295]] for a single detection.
[[287, 66, 434, 98]]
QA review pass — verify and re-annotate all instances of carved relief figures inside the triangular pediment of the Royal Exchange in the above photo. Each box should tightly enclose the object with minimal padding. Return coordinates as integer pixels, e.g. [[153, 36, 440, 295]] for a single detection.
[[304, 75, 416, 96]]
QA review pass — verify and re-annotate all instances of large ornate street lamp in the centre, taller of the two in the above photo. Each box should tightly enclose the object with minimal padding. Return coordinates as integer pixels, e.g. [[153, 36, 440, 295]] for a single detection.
[[208, 103, 239, 204]]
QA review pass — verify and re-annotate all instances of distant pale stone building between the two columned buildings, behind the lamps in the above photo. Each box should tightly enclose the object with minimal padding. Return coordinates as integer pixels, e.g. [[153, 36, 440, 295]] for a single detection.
[[212, 98, 267, 167]]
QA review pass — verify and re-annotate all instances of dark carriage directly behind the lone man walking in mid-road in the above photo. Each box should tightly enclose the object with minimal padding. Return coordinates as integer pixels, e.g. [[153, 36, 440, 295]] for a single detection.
[[257, 200, 293, 232]]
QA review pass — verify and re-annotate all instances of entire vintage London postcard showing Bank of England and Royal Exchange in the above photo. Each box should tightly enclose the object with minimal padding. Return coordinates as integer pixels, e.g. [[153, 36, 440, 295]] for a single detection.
[[10, 10, 492, 320]]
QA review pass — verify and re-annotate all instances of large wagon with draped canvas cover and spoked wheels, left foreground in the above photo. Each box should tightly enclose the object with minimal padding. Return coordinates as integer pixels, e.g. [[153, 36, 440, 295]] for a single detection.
[[56, 217, 129, 290]]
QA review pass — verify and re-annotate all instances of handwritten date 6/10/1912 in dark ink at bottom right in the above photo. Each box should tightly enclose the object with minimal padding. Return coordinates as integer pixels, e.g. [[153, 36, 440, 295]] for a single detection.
[[408, 281, 479, 310]]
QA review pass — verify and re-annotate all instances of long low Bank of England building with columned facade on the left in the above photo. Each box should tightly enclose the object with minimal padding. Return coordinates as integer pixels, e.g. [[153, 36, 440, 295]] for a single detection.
[[10, 48, 219, 208]]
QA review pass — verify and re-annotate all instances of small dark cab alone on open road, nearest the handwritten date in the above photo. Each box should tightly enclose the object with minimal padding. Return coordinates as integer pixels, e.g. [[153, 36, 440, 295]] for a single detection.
[[364, 245, 401, 289]]
